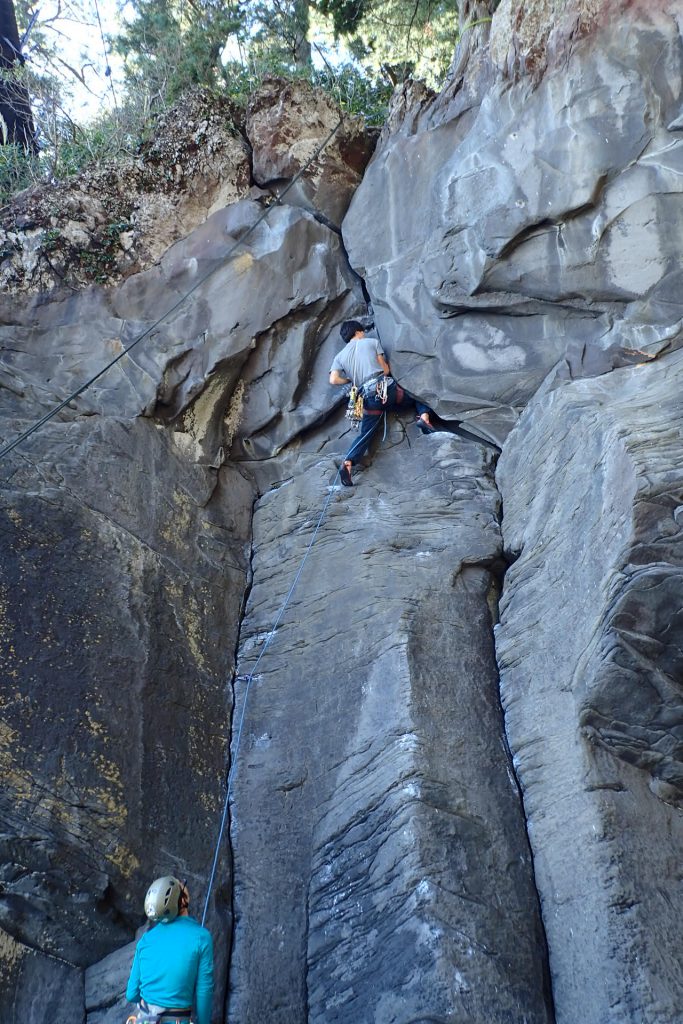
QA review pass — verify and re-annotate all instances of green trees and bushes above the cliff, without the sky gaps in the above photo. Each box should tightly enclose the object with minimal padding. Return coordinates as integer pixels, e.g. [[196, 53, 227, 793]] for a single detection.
[[0, 0, 471, 204]]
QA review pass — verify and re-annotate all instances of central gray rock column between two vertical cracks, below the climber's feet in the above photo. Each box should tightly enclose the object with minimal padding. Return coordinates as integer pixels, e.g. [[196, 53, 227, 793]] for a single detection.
[[228, 427, 552, 1024]]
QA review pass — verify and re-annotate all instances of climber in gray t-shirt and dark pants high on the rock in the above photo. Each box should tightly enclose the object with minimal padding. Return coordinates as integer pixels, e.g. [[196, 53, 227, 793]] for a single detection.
[[330, 321, 435, 487]]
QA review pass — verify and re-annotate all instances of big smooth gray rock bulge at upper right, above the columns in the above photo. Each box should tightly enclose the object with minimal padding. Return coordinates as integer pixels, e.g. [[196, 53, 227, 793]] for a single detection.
[[343, 5, 683, 441]]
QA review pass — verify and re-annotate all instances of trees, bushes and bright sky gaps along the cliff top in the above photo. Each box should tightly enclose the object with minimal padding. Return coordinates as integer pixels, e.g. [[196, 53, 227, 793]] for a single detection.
[[0, 0, 496, 206]]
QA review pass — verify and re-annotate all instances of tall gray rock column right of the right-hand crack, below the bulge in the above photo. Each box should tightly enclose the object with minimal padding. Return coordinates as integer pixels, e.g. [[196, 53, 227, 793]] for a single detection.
[[497, 353, 683, 1024]]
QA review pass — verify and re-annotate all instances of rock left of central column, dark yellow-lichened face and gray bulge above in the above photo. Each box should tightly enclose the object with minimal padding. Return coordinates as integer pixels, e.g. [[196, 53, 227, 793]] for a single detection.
[[0, 81, 368, 1024]]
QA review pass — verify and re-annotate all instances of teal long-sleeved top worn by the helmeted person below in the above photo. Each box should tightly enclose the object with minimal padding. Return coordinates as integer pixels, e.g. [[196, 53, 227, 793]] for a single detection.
[[126, 916, 213, 1024]]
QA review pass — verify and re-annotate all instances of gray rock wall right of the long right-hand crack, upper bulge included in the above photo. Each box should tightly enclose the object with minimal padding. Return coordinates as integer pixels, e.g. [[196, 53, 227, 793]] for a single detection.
[[343, 2, 683, 1024]]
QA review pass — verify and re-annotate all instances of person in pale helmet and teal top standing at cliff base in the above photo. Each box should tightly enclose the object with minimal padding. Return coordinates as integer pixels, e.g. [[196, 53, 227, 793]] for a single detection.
[[126, 874, 213, 1024]]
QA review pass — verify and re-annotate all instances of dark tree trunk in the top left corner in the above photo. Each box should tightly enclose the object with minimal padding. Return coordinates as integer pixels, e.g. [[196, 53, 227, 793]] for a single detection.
[[0, 0, 38, 153]]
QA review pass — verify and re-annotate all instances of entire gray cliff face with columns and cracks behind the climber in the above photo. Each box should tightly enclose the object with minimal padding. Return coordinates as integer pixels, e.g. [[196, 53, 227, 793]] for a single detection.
[[0, 0, 683, 1024]]
